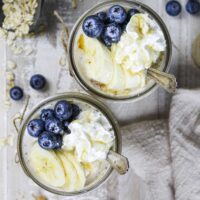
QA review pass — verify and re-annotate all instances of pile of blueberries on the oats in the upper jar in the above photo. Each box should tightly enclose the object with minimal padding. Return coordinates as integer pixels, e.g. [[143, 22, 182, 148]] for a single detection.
[[82, 5, 139, 47]]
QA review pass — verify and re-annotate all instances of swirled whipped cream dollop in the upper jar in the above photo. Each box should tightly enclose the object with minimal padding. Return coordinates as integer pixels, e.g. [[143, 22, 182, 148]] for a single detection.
[[111, 14, 166, 73]]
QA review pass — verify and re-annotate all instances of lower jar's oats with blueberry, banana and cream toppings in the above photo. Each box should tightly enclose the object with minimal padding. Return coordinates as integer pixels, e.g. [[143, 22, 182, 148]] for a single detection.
[[19, 95, 119, 195]]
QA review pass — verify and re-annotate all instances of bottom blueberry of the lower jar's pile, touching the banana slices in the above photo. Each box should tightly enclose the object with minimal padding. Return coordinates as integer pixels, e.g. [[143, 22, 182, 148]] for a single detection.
[[38, 131, 62, 150]]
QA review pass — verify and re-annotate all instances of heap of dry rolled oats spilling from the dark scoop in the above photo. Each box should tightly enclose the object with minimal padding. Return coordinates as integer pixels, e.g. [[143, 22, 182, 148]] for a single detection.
[[0, 0, 38, 54]]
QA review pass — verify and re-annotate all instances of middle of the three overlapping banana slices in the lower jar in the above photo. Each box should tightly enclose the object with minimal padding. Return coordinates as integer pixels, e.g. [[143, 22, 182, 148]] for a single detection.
[[56, 151, 78, 192]]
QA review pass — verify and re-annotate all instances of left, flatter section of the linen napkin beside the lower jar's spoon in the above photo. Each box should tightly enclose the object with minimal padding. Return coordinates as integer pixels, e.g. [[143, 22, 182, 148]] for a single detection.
[[122, 120, 174, 200]]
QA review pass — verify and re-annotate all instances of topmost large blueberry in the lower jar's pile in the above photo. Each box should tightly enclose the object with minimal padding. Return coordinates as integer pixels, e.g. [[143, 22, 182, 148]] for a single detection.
[[54, 100, 73, 120]]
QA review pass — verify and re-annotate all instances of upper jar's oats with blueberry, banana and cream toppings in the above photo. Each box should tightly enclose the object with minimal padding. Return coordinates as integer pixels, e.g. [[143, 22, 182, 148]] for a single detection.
[[69, 1, 171, 100]]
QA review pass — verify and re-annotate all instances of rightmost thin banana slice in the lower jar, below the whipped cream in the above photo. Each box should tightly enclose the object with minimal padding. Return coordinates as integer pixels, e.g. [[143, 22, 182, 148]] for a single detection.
[[64, 152, 86, 190]]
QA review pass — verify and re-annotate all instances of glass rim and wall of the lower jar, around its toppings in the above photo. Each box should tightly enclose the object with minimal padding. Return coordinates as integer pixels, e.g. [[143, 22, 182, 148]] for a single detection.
[[17, 92, 121, 196]]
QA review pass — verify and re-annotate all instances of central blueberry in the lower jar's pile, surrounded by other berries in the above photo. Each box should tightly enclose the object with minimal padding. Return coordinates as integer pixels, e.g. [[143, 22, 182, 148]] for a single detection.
[[45, 118, 62, 134]]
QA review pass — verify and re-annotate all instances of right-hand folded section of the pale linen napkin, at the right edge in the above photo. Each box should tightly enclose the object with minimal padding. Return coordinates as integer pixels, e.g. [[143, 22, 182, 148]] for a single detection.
[[169, 90, 200, 200]]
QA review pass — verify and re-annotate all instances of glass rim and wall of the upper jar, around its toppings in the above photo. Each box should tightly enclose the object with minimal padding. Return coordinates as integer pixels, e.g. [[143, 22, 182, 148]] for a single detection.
[[68, 0, 172, 102]]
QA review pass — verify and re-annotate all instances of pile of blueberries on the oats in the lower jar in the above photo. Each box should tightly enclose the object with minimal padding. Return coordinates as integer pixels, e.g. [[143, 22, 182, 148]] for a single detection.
[[27, 100, 81, 150]]
